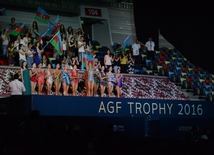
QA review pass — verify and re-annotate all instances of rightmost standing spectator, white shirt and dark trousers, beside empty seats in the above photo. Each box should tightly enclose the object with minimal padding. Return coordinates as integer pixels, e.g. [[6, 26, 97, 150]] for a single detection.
[[145, 37, 155, 60]]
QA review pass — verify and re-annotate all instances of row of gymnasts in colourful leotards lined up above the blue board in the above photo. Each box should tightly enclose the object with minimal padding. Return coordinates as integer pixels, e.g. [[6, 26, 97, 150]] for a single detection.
[[26, 61, 123, 97]]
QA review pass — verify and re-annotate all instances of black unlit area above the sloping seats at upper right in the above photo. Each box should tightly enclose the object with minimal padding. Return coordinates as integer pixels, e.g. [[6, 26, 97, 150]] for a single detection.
[[133, 0, 214, 74]]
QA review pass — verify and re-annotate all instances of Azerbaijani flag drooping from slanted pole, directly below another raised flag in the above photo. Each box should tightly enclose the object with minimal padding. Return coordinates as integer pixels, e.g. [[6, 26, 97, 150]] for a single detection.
[[49, 31, 63, 55]]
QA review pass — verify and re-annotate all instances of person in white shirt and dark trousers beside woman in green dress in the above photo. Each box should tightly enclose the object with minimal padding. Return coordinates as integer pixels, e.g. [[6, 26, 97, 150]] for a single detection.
[[9, 73, 26, 115]]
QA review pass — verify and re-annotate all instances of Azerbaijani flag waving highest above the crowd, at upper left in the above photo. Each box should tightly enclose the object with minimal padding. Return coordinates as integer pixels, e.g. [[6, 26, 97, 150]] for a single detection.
[[34, 7, 50, 24]]
